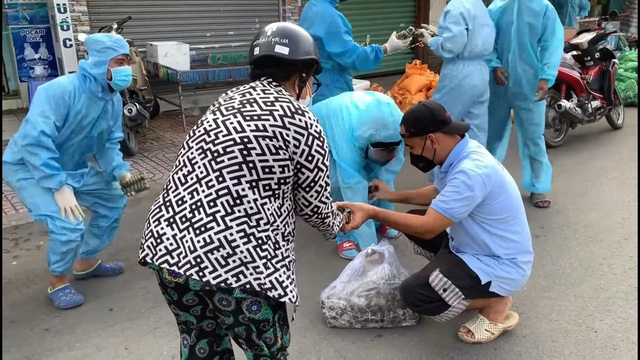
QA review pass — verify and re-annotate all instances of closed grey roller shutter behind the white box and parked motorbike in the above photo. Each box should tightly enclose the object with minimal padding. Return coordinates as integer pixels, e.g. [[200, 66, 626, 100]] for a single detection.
[[87, 0, 281, 91]]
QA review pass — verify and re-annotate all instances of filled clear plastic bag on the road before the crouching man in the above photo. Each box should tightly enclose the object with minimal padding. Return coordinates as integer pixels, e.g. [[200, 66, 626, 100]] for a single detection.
[[320, 241, 419, 329]]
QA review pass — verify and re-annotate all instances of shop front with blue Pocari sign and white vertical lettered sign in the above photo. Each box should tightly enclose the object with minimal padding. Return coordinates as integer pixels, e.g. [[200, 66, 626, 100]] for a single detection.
[[2, 0, 77, 110]]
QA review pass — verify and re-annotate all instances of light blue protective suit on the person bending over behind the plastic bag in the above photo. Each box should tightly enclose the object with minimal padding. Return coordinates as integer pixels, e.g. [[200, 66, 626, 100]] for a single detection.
[[311, 91, 404, 250]]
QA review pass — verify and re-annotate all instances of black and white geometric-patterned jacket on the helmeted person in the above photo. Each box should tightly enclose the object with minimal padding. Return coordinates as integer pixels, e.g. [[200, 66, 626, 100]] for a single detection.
[[138, 80, 341, 305]]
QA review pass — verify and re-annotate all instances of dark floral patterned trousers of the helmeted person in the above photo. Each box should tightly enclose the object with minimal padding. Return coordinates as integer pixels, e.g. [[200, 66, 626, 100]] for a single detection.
[[151, 266, 290, 360]]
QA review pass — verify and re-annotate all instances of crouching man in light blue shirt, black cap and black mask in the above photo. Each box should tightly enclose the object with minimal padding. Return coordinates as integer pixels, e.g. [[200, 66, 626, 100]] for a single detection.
[[338, 100, 533, 343]]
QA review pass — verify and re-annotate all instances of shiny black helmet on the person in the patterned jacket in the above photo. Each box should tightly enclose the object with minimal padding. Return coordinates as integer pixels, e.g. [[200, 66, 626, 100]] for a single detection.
[[249, 22, 322, 75]]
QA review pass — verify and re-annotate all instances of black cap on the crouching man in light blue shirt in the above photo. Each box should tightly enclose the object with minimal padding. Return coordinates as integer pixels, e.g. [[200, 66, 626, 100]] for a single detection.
[[400, 100, 469, 138]]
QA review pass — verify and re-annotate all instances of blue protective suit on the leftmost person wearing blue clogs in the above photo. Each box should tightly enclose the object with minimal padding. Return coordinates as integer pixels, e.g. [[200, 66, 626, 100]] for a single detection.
[[2, 34, 129, 275]]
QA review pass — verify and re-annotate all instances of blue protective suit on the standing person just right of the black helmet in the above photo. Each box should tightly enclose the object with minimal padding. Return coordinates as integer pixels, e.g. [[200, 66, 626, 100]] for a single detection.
[[298, 0, 384, 104]]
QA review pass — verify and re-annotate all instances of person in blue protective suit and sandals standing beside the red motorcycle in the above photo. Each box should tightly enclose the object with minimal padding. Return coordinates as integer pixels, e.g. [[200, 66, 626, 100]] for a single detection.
[[487, 0, 564, 208]]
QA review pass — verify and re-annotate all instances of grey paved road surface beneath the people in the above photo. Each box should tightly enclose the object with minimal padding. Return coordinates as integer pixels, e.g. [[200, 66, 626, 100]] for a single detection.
[[2, 109, 638, 360]]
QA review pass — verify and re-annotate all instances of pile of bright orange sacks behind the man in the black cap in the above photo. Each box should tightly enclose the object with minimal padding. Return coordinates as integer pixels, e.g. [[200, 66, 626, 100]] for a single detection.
[[388, 60, 440, 112]]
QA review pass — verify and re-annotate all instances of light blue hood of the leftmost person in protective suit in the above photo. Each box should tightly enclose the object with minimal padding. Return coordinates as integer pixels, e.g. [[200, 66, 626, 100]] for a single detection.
[[79, 34, 129, 94]]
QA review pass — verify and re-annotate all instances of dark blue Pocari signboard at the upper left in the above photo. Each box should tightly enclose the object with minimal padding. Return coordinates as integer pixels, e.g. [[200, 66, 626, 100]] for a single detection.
[[5, 3, 58, 83]]
